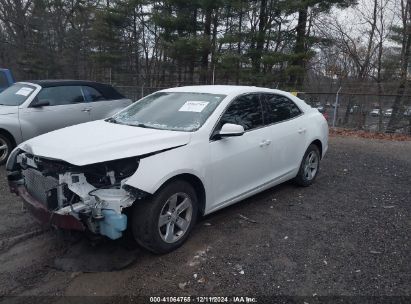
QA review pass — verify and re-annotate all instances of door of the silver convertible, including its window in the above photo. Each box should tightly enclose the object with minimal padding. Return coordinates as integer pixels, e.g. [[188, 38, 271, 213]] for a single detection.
[[19, 86, 90, 140]]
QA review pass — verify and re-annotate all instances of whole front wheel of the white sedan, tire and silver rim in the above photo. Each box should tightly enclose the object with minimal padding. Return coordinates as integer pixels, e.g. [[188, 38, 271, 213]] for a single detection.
[[132, 180, 198, 253]]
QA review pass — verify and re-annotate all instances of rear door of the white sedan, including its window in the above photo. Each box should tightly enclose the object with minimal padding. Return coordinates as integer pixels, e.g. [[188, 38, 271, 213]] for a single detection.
[[262, 93, 307, 179]]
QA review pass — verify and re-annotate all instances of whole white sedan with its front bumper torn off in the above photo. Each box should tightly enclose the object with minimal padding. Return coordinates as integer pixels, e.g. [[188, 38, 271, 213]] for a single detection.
[[7, 86, 328, 253]]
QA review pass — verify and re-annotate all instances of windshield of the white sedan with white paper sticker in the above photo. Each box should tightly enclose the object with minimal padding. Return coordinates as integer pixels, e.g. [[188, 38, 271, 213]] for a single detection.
[[111, 92, 226, 132]]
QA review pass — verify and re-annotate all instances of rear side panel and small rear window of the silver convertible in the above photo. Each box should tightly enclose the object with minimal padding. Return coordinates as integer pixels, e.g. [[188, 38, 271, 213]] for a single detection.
[[82, 86, 131, 120]]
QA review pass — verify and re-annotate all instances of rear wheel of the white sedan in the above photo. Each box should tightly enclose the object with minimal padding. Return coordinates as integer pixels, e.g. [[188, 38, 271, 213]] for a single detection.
[[294, 144, 320, 187]]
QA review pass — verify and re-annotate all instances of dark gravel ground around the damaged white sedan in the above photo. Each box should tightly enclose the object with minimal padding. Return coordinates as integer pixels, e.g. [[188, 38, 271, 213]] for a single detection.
[[0, 137, 411, 303]]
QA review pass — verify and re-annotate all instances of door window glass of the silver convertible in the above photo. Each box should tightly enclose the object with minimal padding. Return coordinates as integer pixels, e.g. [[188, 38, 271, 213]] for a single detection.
[[37, 86, 84, 106]]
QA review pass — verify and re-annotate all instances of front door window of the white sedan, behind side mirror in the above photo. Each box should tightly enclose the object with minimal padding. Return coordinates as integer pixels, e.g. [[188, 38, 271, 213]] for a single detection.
[[217, 94, 263, 131]]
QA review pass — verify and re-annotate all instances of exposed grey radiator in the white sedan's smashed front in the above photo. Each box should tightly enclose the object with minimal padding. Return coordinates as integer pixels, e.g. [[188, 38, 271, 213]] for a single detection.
[[23, 168, 58, 209]]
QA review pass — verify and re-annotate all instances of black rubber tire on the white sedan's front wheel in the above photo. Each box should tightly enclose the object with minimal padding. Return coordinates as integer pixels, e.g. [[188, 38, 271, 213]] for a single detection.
[[131, 180, 198, 254]]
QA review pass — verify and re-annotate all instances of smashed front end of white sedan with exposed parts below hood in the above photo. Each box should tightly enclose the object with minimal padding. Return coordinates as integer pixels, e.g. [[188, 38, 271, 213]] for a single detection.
[[6, 149, 149, 239]]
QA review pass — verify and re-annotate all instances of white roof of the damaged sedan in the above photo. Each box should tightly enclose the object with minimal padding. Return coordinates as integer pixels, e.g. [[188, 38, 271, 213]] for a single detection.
[[161, 85, 288, 95]]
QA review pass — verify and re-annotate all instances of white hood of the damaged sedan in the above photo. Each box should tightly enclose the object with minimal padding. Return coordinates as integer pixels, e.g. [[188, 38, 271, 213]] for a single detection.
[[19, 120, 190, 166]]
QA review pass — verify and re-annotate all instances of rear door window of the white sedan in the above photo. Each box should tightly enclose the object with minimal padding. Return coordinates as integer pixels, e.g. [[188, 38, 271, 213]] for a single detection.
[[263, 94, 301, 125]]
